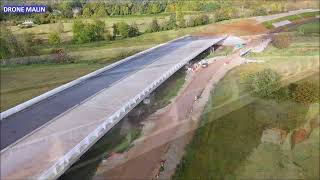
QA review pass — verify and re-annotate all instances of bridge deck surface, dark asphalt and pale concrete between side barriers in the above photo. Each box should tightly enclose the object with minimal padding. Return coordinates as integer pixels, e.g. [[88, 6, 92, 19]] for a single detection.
[[1, 37, 222, 179]]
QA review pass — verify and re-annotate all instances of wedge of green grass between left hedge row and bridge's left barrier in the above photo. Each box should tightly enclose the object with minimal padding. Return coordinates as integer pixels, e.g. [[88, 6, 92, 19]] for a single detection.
[[0, 64, 102, 112]]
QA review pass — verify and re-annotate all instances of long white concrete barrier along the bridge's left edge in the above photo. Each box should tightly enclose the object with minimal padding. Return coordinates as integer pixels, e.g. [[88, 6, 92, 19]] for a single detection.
[[0, 35, 189, 120]]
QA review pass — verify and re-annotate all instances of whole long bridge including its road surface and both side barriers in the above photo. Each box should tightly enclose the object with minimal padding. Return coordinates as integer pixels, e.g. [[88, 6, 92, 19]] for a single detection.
[[0, 36, 225, 179]]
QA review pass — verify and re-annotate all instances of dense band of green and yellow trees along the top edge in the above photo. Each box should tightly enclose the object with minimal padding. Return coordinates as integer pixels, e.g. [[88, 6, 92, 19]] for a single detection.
[[0, 0, 287, 24]]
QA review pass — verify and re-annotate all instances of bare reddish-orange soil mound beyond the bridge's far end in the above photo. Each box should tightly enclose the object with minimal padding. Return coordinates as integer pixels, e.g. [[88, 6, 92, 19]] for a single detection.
[[194, 19, 268, 36]]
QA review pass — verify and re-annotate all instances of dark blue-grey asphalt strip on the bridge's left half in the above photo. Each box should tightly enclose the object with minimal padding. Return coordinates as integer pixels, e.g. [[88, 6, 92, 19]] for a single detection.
[[0, 37, 196, 150]]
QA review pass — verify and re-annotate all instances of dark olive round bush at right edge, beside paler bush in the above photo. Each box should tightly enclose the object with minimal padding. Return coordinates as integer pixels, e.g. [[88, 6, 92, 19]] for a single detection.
[[292, 82, 319, 104]]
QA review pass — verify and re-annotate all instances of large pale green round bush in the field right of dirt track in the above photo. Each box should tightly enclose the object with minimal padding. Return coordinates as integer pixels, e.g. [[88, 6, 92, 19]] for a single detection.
[[245, 69, 281, 99]]
